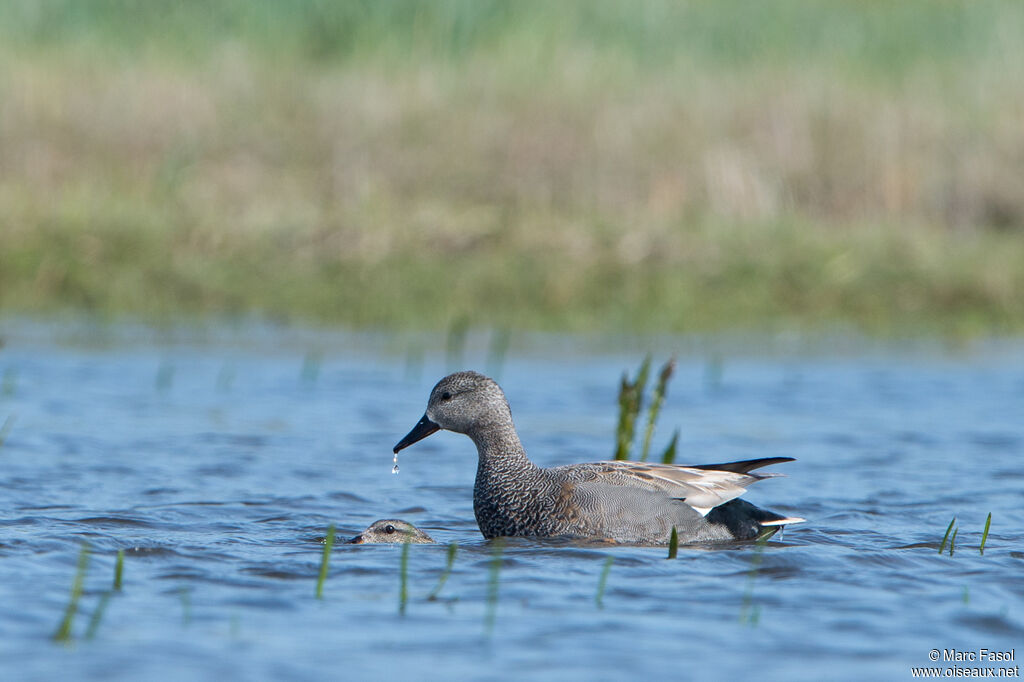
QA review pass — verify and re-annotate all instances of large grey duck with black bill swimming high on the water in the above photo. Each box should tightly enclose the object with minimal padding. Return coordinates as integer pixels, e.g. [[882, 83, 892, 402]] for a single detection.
[[394, 372, 804, 545]]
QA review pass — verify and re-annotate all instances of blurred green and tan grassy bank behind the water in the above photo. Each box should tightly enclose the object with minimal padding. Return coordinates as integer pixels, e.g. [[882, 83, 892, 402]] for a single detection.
[[0, 0, 1024, 334]]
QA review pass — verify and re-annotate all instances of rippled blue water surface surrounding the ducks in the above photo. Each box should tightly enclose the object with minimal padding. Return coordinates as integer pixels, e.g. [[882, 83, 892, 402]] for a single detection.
[[0, 328, 1024, 680]]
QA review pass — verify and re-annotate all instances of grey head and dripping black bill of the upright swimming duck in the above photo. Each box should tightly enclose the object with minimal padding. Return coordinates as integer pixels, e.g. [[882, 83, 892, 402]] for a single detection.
[[394, 372, 512, 453]]
